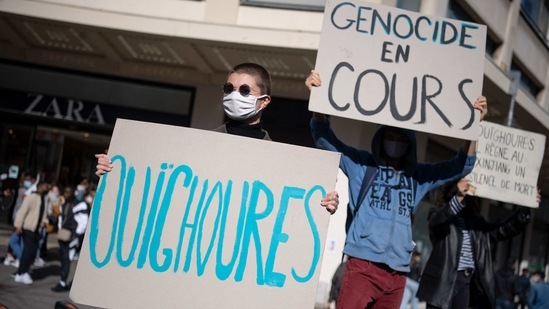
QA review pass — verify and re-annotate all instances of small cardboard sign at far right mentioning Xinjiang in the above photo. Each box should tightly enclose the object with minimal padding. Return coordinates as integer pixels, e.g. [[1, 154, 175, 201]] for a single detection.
[[467, 121, 545, 208]]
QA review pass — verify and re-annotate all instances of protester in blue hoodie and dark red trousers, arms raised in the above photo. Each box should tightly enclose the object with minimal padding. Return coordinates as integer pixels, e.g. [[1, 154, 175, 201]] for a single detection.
[[305, 71, 487, 309]]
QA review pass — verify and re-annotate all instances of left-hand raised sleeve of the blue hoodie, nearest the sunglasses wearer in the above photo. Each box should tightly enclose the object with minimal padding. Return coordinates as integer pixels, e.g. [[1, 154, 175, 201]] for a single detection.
[[311, 119, 370, 179]]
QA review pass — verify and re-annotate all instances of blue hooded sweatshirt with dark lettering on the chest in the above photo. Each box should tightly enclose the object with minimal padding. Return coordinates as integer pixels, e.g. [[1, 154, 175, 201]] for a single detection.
[[311, 119, 476, 272]]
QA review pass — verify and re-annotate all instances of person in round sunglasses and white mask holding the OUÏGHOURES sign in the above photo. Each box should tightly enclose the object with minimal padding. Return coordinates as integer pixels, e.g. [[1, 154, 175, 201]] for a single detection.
[[95, 63, 339, 213]]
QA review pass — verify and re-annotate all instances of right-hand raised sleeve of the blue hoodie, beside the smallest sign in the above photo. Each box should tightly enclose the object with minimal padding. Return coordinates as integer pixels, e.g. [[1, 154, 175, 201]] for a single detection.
[[416, 149, 477, 192]]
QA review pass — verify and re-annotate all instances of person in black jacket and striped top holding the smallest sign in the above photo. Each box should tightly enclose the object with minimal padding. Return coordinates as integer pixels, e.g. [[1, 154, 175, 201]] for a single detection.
[[417, 178, 541, 309]]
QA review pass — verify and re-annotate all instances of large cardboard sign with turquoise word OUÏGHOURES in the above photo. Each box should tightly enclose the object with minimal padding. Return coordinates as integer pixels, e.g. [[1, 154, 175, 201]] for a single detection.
[[70, 119, 340, 308]]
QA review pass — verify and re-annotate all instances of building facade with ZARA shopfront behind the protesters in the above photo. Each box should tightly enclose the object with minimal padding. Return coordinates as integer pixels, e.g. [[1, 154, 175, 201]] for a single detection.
[[0, 0, 549, 303]]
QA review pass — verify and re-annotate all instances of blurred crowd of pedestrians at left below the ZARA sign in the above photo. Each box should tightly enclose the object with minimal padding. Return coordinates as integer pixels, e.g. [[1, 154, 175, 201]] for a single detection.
[[1, 172, 95, 292]]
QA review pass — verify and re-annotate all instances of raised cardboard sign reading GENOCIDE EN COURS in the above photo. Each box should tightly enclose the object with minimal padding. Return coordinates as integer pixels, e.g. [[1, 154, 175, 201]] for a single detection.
[[309, 0, 486, 139]]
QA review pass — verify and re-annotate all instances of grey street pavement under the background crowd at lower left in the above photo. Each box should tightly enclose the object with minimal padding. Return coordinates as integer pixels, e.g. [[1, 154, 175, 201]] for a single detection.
[[0, 223, 101, 309]]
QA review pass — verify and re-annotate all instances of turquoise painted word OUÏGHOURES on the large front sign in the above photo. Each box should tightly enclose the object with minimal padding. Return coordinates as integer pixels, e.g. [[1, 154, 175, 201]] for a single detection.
[[89, 155, 326, 287]]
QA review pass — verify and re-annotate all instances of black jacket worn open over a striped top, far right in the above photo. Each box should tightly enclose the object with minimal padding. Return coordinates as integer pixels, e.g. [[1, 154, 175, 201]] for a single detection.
[[417, 199, 530, 309]]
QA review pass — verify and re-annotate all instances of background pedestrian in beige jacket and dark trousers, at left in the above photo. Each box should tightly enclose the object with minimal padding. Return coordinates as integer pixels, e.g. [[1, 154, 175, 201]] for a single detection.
[[13, 181, 49, 284]]
